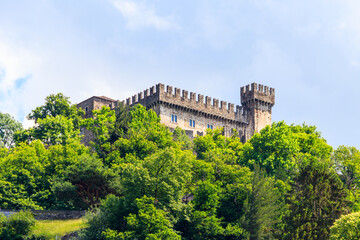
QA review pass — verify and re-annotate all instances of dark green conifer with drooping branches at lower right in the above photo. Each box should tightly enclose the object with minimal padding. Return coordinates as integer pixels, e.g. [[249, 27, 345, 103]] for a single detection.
[[284, 156, 349, 239]]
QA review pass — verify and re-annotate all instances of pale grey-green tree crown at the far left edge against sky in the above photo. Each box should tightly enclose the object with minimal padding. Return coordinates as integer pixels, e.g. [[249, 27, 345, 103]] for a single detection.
[[0, 112, 23, 148]]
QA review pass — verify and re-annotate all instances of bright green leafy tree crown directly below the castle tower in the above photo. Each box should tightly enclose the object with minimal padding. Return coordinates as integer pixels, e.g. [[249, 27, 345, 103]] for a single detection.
[[240, 122, 332, 180]]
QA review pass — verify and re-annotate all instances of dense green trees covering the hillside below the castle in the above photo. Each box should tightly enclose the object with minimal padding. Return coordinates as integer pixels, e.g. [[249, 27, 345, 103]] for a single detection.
[[0, 94, 360, 240]]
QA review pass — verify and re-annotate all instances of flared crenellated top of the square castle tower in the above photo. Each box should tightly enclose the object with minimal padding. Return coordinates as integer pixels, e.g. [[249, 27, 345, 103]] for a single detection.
[[240, 83, 275, 106]]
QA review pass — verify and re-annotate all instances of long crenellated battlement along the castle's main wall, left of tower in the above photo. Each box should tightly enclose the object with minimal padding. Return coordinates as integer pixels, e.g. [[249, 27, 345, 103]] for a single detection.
[[124, 83, 244, 120]]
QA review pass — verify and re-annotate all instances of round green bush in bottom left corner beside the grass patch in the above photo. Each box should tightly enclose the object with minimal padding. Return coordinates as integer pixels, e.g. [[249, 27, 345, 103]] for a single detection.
[[0, 211, 35, 240]]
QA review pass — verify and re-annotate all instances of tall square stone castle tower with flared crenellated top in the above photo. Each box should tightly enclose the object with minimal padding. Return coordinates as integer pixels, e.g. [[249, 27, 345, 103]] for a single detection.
[[240, 83, 275, 139]]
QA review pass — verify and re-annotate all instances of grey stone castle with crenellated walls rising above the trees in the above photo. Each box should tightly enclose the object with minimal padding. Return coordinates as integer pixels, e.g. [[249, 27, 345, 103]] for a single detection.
[[77, 83, 275, 144]]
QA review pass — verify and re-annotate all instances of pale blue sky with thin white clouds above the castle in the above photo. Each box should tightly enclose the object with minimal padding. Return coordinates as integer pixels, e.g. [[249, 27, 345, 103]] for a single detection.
[[0, 0, 360, 148]]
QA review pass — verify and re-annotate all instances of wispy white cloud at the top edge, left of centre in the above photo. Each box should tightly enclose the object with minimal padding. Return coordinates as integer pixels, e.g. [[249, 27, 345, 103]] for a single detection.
[[113, 0, 177, 30]]
